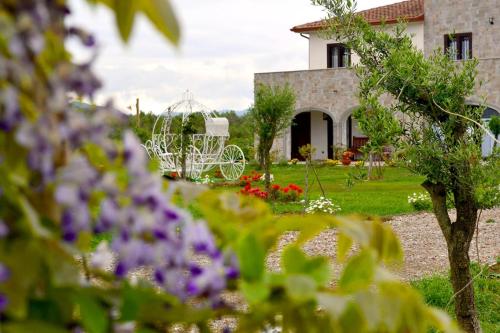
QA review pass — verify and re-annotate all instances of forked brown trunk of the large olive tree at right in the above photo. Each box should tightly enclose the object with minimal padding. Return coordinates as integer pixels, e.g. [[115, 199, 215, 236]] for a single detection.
[[422, 181, 481, 333]]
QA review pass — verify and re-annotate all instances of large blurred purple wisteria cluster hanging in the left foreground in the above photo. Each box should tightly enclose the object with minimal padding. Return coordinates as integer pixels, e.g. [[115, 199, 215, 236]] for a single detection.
[[0, 1, 238, 306]]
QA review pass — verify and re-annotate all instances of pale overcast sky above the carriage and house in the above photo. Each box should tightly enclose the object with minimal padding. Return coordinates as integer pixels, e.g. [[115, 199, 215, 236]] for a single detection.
[[68, 0, 400, 113]]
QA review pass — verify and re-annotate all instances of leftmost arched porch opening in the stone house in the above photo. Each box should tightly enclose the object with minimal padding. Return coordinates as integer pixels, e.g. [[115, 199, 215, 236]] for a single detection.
[[290, 111, 333, 161]]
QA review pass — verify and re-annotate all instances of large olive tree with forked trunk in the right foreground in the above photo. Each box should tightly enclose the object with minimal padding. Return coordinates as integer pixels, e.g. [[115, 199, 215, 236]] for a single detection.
[[313, 0, 498, 332]]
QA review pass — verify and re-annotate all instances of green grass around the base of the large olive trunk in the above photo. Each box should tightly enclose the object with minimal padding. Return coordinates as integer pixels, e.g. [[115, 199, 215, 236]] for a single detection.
[[412, 264, 500, 333]]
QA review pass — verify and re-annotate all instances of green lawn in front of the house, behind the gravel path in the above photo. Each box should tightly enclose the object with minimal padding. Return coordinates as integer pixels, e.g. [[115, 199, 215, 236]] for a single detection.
[[209, 165, 423, 216]]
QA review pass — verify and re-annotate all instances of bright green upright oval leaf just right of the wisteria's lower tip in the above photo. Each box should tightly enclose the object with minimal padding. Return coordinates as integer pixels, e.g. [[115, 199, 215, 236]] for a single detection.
[[237, 234, 266, 281]]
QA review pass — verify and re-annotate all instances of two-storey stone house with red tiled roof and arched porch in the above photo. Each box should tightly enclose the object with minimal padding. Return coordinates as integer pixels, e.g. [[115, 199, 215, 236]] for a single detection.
[[254, 0, 500, 160]]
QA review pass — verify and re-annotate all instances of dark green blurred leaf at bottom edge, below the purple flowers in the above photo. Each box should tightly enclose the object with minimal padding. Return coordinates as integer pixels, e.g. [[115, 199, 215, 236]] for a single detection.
[[76, 292, 109, 333]]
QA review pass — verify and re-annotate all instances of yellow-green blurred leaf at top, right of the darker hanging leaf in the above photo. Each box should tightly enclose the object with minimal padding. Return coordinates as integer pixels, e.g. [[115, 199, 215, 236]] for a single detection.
[[138, 0, 180, 45]]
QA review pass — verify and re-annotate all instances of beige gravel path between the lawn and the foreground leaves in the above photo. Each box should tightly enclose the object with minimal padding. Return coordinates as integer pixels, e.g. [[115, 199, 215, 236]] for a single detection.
[[267, 208, 500, 280]]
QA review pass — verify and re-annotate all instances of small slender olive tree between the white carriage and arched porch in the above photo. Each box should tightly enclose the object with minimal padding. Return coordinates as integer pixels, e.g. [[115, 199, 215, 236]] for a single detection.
[[250, 84, 295, 191]]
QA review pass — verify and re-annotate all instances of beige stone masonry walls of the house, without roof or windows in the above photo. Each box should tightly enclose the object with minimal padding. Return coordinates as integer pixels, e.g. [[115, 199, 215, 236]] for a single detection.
[[255, 0, 500, 159]]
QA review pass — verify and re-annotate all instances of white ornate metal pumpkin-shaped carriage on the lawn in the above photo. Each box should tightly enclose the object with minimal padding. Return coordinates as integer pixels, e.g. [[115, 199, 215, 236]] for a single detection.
[[145, 92, 245, 180]]
